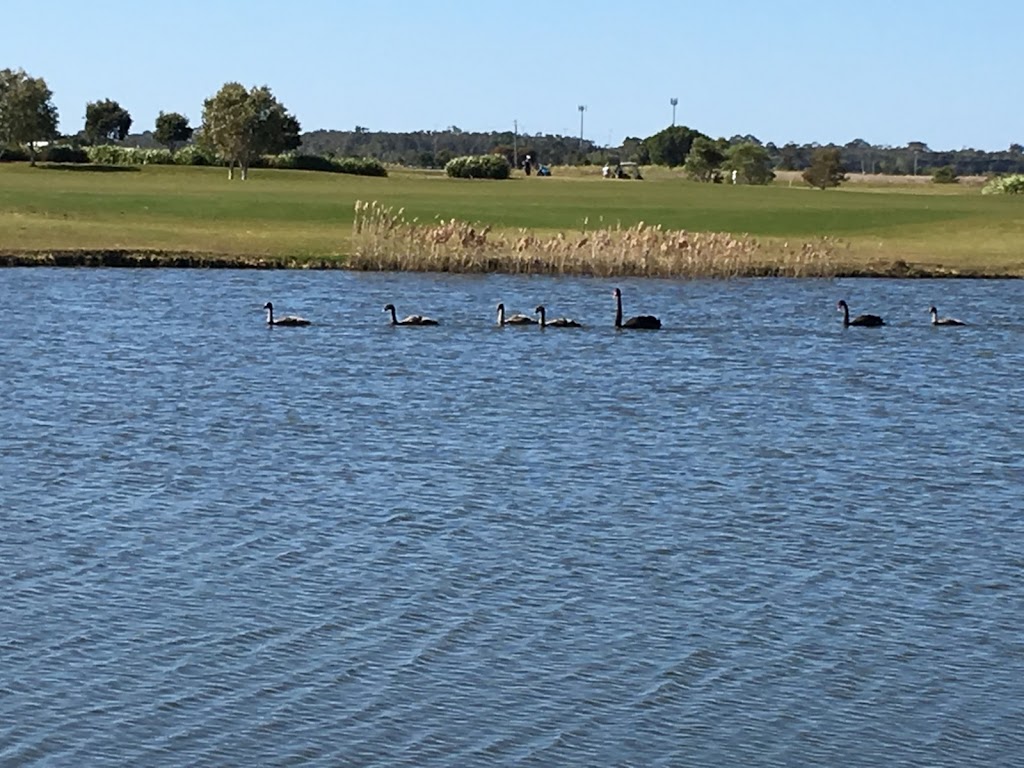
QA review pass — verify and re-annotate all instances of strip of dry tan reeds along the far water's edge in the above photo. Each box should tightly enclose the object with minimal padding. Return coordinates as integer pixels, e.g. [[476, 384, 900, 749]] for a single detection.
[[348, 201, 843, 279]]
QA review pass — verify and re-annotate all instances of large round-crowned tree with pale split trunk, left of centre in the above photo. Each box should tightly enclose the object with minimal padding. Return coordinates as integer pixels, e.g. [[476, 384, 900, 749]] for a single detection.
[[202, 83, 300, 180]]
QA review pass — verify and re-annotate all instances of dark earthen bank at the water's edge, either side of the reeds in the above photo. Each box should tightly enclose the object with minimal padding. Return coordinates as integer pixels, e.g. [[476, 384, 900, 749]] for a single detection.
[[0, 249, 1022, 280]]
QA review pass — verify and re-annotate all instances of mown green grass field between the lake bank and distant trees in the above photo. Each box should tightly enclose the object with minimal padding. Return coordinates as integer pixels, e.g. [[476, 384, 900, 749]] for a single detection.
[[0, 164, 1024, 274]]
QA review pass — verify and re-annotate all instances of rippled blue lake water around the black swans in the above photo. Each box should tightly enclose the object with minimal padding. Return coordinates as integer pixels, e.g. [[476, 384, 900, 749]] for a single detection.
[[0, 268, 1024, 767]]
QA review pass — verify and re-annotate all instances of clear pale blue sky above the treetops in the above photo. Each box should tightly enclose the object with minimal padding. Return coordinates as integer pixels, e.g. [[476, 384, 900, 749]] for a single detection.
[[0, 0, 1024, 151]]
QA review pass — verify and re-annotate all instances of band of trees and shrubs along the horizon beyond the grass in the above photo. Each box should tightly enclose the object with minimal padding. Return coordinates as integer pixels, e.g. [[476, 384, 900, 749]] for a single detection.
[[0, 69, 1024, 183]]
